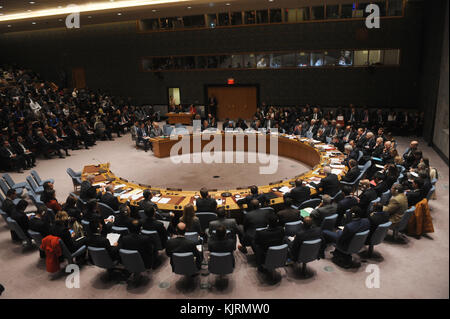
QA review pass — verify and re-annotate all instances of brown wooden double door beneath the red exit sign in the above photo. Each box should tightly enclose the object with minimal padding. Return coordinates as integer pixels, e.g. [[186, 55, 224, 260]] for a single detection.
[[208, 86, 258, 121]]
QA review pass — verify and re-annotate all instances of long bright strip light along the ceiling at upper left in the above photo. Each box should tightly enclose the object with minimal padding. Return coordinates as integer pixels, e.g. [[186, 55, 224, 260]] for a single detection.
[[0, 0, 192, 22]]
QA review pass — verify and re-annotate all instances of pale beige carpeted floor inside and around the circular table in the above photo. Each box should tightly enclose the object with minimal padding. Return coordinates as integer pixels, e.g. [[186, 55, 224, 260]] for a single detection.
[[0, 131, 449, 299]]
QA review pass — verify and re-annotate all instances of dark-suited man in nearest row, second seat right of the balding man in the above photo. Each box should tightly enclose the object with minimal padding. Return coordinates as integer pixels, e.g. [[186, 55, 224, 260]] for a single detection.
[[253, 214, 284, 272]]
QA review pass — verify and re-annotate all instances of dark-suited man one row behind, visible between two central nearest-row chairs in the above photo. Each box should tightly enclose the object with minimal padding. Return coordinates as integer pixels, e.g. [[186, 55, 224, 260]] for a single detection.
[[240, 199, 273, 253]]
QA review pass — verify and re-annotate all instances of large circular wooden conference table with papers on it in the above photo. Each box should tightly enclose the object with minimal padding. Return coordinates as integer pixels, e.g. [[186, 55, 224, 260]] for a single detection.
[[82, 132, 347, 218]]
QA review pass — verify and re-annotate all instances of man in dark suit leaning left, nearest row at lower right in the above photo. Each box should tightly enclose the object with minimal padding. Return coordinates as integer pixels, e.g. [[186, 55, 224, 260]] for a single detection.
[[323, 206, 370, 268]]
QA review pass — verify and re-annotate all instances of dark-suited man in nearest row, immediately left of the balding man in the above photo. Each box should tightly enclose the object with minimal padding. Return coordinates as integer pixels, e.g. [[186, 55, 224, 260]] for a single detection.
[[118, 219, 158, 269]]
